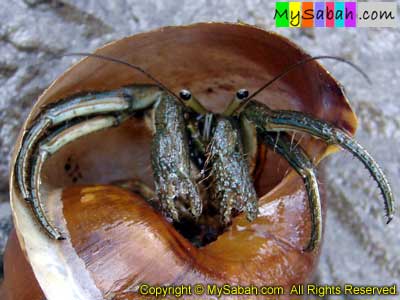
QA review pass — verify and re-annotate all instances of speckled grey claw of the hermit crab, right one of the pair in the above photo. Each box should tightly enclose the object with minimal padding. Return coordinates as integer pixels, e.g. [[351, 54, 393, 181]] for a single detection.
[[207, 117, 258, 223]]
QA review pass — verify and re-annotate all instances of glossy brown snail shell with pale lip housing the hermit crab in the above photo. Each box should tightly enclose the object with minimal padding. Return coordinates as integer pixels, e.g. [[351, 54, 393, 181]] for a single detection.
[[0, 23, 357, 300]]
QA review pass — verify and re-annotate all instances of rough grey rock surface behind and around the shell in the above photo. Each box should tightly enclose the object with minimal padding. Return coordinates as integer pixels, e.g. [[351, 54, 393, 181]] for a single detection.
[[0, 0, 400, 299]]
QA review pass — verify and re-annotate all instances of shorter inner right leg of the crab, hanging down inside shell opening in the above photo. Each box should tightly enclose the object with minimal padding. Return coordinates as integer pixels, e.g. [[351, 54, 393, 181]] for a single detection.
[[258, 130, 322, 251]]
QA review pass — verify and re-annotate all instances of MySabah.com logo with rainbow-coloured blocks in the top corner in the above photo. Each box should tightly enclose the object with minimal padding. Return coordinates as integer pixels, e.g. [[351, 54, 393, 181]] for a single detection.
[[274, 2, 398, 27]]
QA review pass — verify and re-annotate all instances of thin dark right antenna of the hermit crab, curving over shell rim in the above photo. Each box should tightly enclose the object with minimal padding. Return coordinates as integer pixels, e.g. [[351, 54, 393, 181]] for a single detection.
[[235, 55, 372, 112]]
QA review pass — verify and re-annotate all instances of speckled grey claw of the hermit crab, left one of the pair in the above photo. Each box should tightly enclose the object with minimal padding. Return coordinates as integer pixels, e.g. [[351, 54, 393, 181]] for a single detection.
[[151, 93, 202, 221]]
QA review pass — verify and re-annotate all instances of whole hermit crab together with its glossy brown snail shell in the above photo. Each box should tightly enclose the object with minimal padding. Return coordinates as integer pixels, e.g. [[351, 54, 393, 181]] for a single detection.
[[1, 23, 393, 299]]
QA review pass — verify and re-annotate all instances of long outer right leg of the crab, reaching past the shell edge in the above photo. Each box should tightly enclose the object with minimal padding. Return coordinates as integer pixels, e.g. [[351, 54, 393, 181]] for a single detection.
[[243, 101, 394, 223]]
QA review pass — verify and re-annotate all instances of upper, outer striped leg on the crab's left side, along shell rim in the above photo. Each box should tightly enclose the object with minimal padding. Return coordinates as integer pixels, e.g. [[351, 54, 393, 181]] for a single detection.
[[16, 85, 161, 201]]
